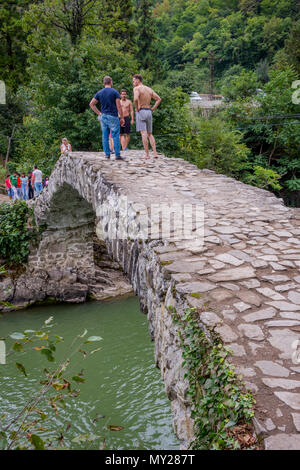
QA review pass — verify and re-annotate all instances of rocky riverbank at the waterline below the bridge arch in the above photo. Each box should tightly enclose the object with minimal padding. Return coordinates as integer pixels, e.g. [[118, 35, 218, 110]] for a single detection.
[[0, 238, 133, 312]]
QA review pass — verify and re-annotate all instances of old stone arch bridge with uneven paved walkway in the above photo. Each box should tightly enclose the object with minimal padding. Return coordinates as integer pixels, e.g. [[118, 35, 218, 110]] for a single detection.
[[30, 151, 300, 449]]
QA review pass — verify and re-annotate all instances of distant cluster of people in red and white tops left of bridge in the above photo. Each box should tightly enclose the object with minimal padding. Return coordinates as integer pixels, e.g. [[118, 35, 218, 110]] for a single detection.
[[5, 165, 49, 201]]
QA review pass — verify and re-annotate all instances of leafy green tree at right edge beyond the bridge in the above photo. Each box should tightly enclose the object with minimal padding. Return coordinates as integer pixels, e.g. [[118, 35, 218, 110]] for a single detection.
[[226, 66, 300, 191]]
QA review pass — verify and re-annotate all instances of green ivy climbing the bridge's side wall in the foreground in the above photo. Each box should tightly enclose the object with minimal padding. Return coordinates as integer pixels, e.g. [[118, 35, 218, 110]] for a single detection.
[[169, 307, 257, 449]]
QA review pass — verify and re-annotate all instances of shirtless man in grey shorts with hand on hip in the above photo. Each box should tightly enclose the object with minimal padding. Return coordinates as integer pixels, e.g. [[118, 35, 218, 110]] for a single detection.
[[132, 74, 161, 159]]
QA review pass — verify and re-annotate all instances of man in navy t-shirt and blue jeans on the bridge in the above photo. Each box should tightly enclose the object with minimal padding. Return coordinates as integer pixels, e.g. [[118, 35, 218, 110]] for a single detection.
[[90, 76, 125, 160]]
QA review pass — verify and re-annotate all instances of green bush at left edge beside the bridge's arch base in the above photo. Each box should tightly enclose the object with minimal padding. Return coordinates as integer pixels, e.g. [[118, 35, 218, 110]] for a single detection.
[[0, 201, 33, 265]]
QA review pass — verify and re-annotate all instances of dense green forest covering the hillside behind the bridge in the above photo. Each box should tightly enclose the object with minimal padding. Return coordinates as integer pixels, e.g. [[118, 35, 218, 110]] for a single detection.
[[0, 0, 300, 198]]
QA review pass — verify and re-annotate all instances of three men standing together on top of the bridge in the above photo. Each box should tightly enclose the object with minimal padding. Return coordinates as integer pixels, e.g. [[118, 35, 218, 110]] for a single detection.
[[90, 74, 161, 160]]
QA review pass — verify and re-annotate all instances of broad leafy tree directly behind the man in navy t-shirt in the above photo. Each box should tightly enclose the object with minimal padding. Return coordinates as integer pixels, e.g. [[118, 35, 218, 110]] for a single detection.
[[16, 36, 137, 174]]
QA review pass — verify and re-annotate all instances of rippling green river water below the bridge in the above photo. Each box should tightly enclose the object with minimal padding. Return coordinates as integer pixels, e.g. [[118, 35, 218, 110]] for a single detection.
[[0, 297, 179, 450]]
